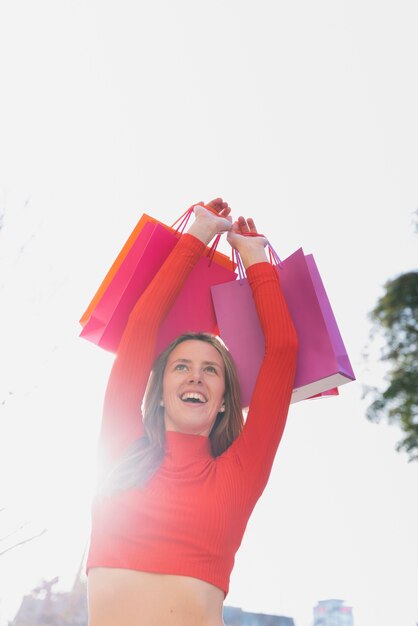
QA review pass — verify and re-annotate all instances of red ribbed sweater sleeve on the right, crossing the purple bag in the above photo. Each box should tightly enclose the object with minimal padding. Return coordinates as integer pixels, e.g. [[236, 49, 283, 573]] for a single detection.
[[227, 263, 297, 498]]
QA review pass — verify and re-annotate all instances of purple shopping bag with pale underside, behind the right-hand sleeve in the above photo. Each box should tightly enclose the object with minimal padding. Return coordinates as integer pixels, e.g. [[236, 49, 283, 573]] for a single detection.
[[212, 248, 355, 406]]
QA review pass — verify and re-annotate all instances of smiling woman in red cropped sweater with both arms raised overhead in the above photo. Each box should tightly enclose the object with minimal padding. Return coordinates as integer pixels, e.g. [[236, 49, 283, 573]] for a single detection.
[[87, 198, 297, 626]]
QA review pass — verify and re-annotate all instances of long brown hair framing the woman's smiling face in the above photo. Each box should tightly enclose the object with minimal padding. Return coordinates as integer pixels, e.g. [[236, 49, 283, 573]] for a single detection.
[[100, 333, 243, 494]]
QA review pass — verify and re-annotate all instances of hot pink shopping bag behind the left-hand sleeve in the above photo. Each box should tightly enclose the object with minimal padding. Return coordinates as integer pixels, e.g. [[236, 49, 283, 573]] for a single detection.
[[80, 222, 235, 352]]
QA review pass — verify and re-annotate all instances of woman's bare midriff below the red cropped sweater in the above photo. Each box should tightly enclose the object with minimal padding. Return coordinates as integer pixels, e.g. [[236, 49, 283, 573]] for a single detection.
[[88, 567, 225, 626]]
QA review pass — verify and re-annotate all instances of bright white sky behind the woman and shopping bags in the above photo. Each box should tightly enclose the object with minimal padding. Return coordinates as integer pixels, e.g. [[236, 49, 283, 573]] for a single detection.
[[0, 0, 418, 626]]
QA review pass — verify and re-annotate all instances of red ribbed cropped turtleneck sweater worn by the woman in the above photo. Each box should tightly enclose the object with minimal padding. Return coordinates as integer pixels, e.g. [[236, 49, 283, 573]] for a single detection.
[[87, 234, 297, 594]]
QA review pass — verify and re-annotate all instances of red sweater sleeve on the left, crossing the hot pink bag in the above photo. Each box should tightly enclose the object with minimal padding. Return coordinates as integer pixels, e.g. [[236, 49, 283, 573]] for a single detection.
[[99, 234, 205, 466]]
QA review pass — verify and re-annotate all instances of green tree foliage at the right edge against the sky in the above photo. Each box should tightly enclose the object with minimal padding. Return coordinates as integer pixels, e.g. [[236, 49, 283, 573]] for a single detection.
[[367, 271, 418, 461]]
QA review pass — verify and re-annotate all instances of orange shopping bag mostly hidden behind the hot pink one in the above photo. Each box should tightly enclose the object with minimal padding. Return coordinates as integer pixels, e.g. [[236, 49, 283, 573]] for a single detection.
[[80, 202, 231, 326]]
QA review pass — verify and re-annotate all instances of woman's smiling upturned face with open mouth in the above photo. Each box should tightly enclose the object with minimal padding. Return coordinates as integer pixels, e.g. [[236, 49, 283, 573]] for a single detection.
[[163, 339, 225, 436]]
